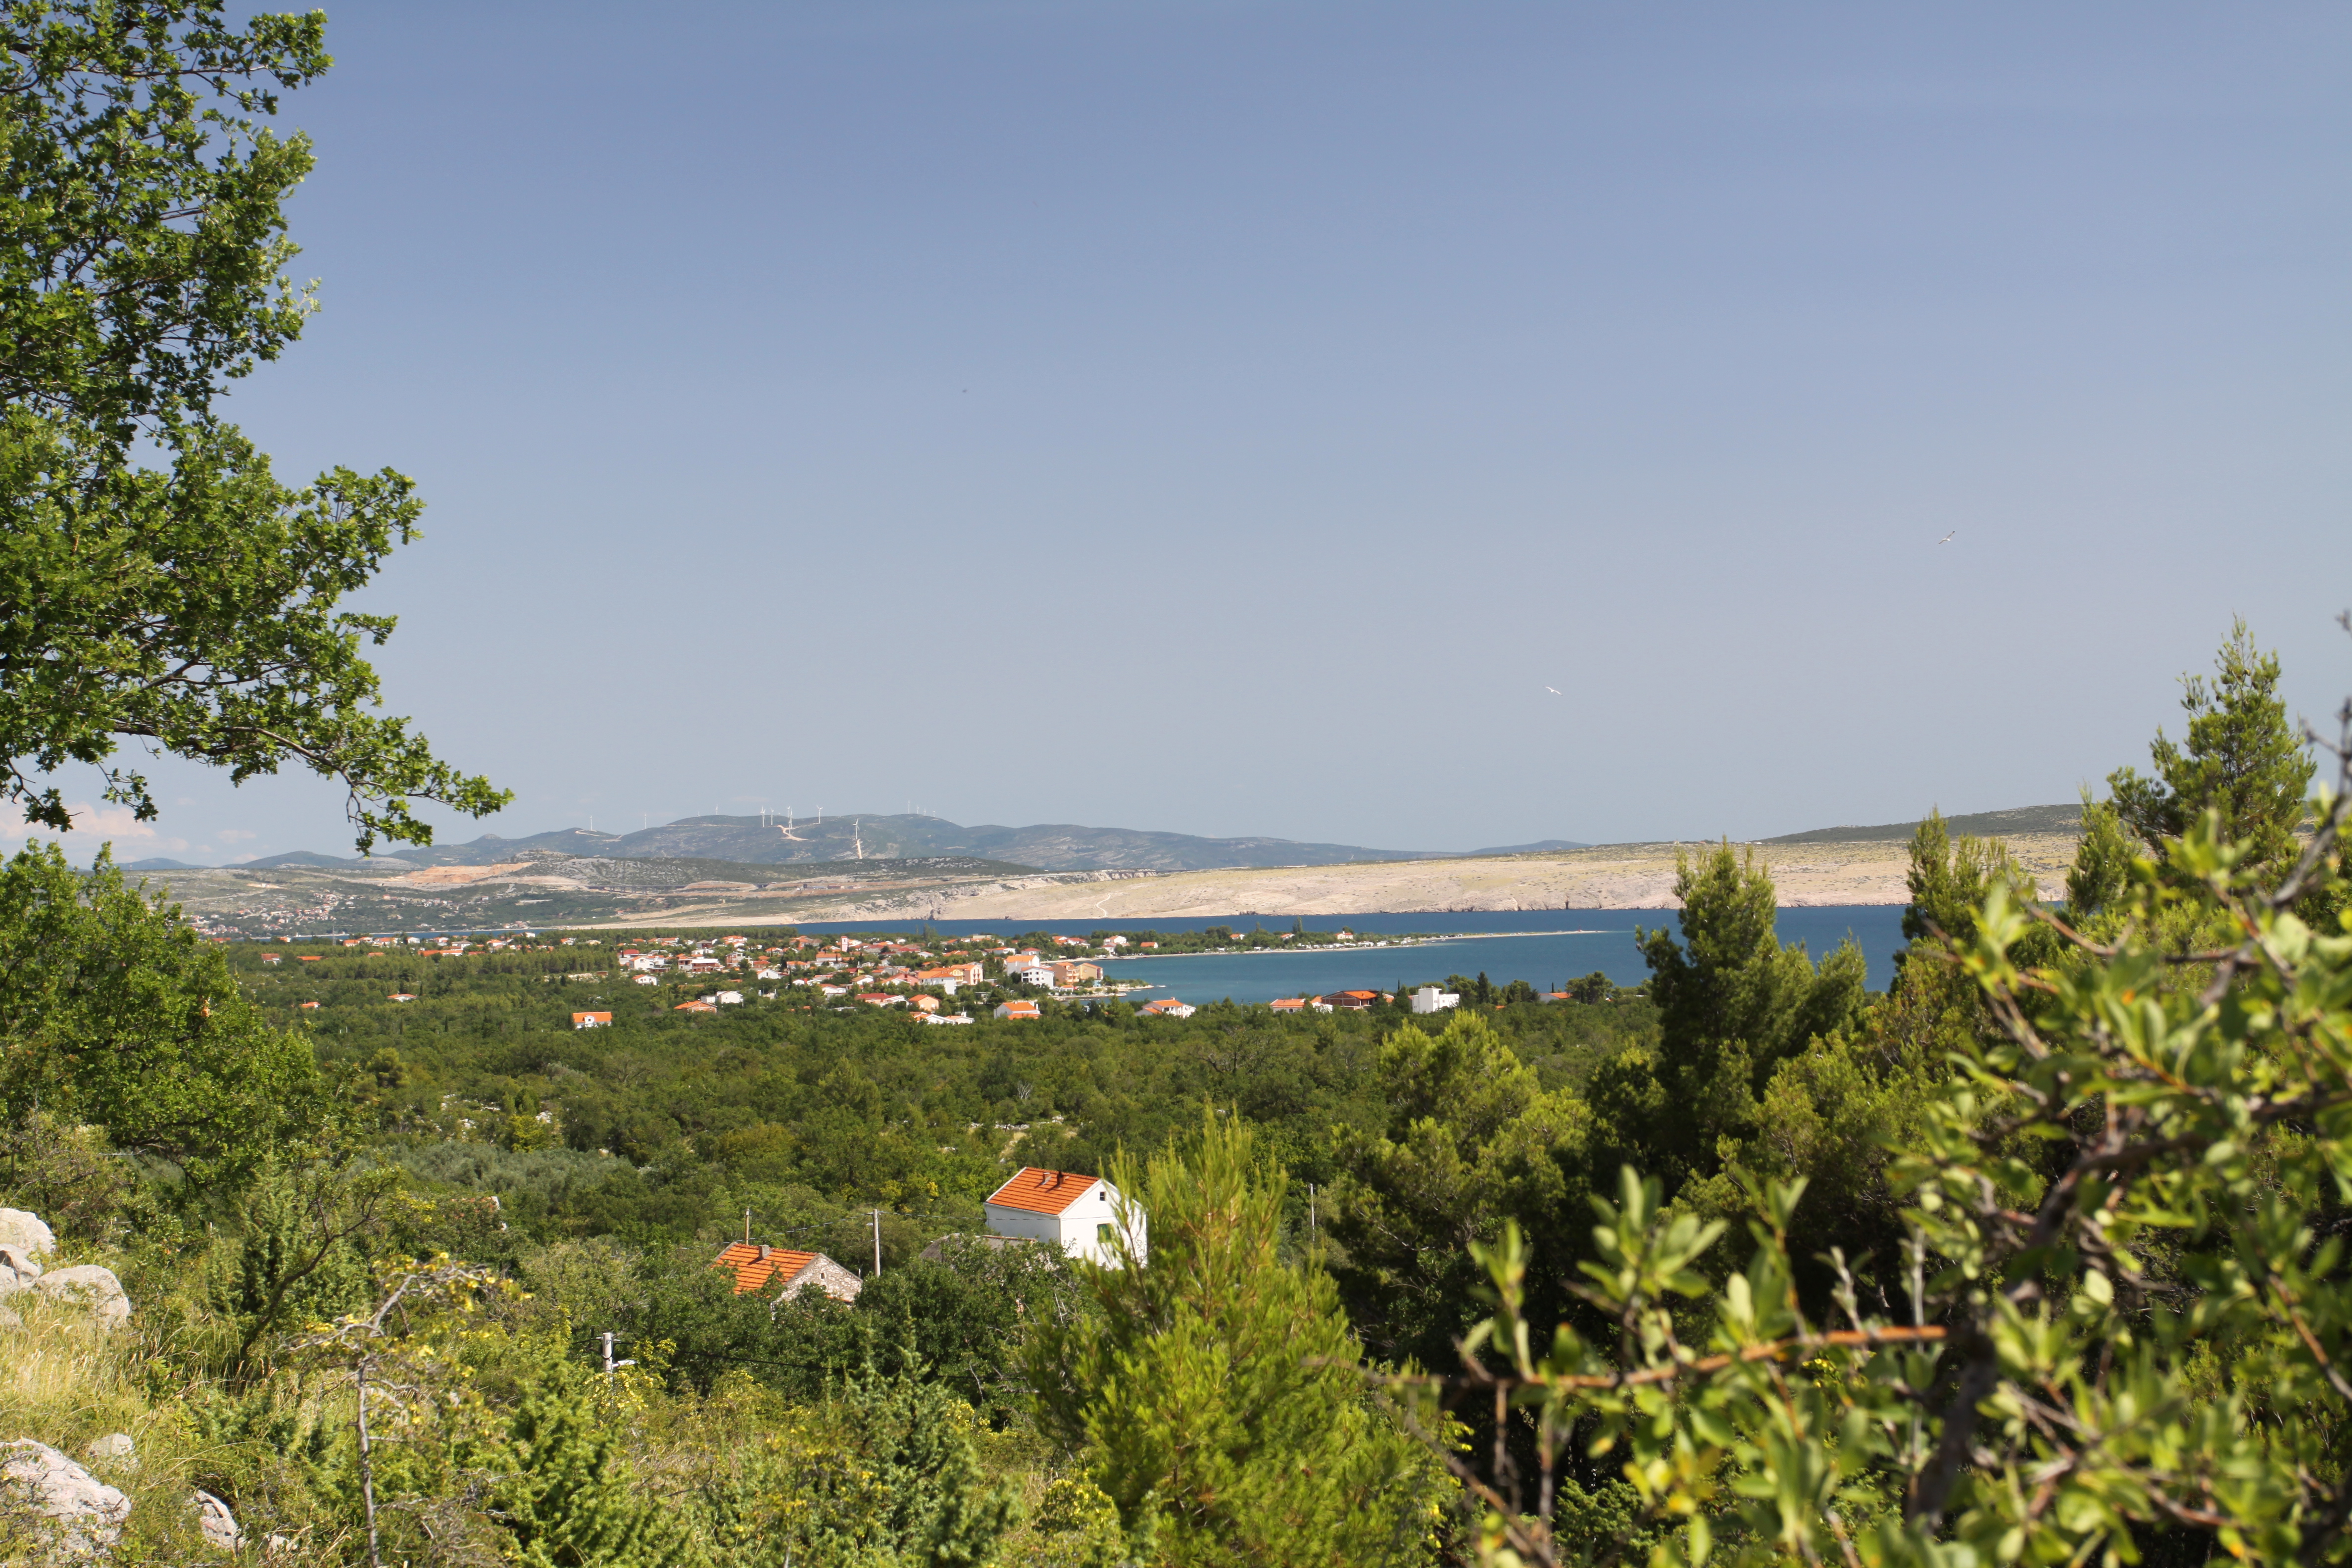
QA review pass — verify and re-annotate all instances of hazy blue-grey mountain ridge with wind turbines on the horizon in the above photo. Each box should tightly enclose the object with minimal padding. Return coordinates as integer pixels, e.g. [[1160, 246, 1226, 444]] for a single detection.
[[245, 816, 1588, 872]]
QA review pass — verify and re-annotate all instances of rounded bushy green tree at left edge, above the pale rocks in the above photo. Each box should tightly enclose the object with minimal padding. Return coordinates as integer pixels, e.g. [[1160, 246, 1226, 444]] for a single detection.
[[0, 846, 329, 1185]]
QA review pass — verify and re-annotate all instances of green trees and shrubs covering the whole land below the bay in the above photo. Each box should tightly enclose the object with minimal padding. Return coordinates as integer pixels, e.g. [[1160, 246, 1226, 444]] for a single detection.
[[0, 620, 2352, 1566]]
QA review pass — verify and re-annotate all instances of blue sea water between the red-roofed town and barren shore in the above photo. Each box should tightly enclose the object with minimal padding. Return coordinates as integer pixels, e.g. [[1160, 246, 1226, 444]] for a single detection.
[[800, 903, 1903, 1006]]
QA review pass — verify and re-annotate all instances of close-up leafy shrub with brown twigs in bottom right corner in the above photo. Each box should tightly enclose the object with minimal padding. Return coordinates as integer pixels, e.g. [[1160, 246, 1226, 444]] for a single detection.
[[1392, 667, 2352, 1566]]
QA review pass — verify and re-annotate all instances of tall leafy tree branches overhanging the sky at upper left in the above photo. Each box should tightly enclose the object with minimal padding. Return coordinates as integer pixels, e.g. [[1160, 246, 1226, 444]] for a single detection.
[[0, 0, 508, 849]]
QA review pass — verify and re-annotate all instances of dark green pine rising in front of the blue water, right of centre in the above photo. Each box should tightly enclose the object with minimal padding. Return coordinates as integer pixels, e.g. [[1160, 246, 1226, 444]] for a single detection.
[[1632, 839, 1867, 1185]]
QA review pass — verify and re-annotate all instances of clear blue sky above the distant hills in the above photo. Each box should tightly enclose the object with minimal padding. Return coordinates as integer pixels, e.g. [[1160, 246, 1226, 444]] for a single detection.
[[18, 0, 2352, 860]]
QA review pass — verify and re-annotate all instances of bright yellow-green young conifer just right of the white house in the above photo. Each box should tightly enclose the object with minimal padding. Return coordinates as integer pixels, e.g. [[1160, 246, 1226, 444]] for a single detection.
[[1026, 1112, 1442, 1566]]
